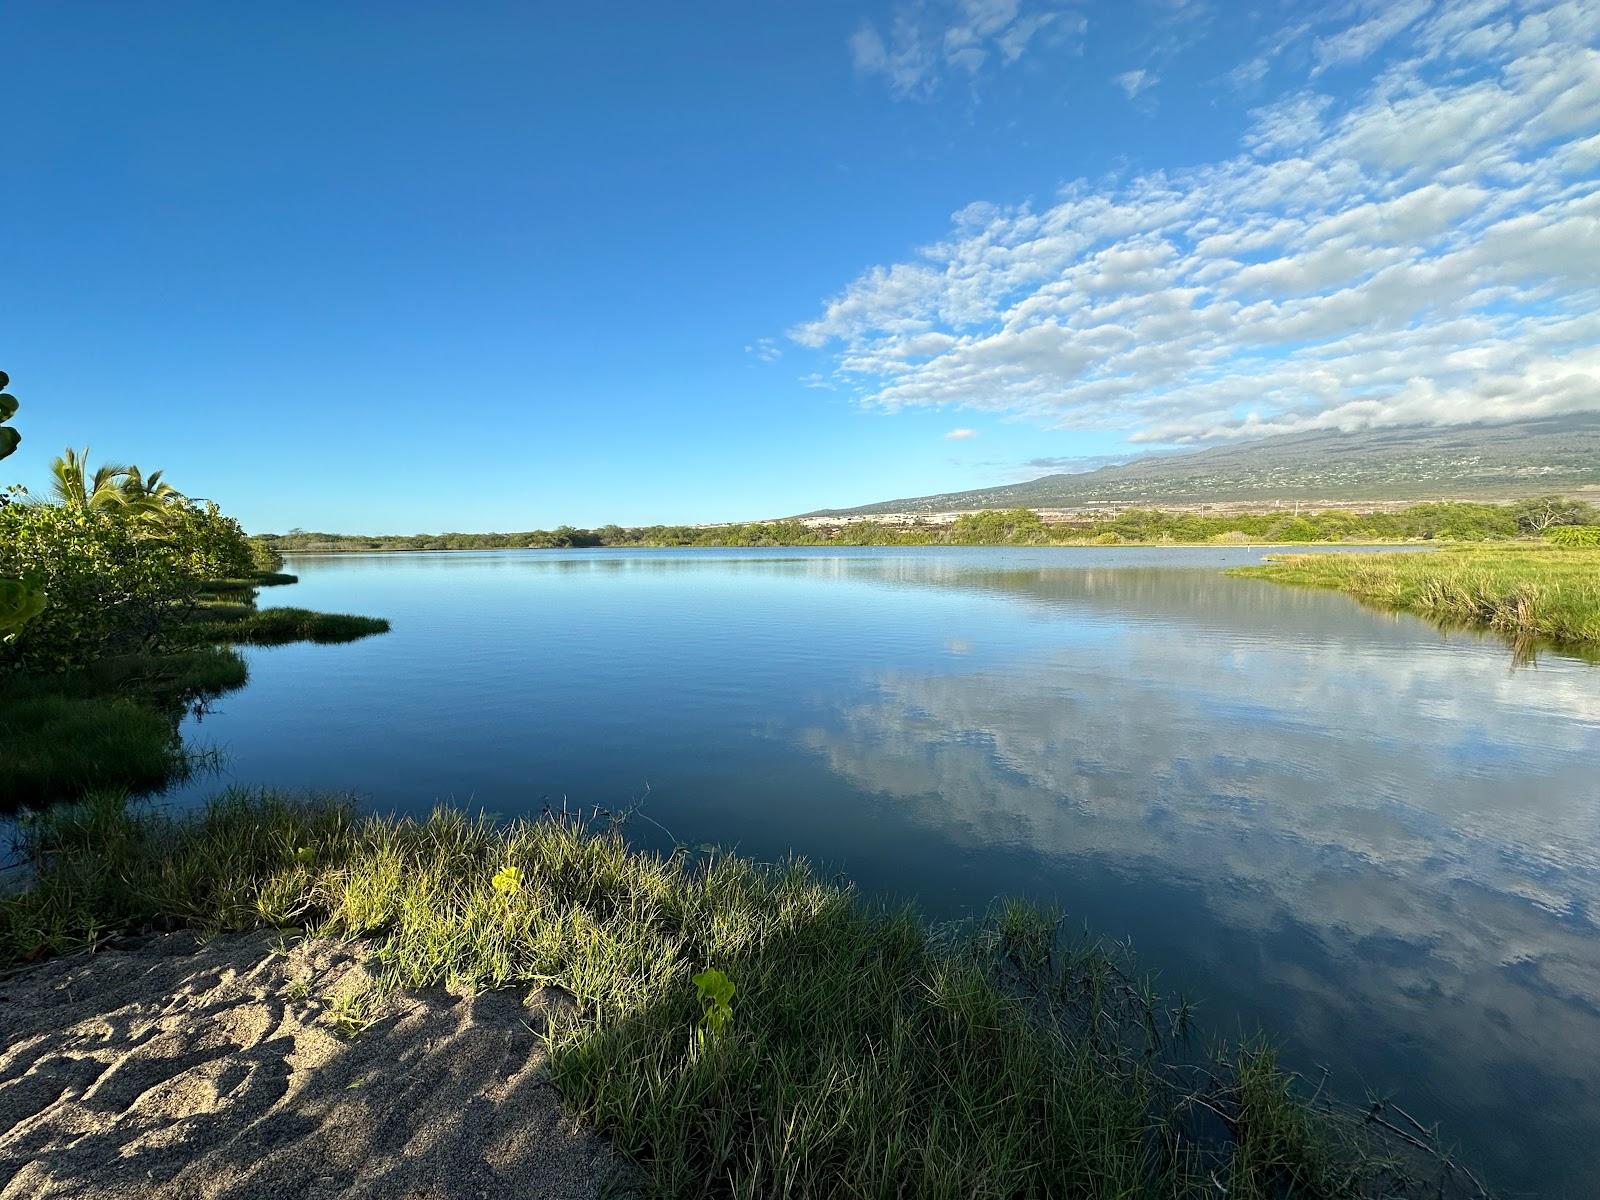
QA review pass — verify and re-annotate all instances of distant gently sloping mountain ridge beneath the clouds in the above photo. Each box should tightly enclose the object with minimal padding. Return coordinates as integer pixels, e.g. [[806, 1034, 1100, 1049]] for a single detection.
[[805, 413, 1600, 517]]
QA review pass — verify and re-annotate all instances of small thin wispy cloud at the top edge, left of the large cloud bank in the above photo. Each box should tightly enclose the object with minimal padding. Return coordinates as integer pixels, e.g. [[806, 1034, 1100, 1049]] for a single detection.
[[850, 0, 1086, 99]]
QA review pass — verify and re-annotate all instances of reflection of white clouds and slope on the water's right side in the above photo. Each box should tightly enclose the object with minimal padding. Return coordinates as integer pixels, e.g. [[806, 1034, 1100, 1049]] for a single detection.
[[787, 563, 1600, 1196]]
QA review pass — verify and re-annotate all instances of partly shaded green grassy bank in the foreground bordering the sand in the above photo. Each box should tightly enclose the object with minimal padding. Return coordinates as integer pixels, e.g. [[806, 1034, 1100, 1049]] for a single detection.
[[0, 794, 1474, 1200]]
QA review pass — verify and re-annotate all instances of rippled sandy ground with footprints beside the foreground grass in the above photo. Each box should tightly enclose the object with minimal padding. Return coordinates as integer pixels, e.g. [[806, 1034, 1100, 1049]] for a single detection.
[[0, 934, 622, 1200]]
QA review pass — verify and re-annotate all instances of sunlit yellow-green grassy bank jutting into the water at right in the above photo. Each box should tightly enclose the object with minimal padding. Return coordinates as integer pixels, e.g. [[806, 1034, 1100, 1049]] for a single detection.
[[1234, 542, 1600, 650]]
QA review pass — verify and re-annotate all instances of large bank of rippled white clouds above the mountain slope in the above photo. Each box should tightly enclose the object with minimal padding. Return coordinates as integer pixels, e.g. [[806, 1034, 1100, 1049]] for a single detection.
[[806, 0, 1600, 442]]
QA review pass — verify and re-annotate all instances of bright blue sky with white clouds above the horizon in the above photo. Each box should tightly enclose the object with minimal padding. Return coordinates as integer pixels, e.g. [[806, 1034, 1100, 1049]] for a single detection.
[[0, 0, 1600, 533]]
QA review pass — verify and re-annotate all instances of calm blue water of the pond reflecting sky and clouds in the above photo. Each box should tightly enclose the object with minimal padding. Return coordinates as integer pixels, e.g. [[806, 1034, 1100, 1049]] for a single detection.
[[165, 550, 1600, 1197]]
